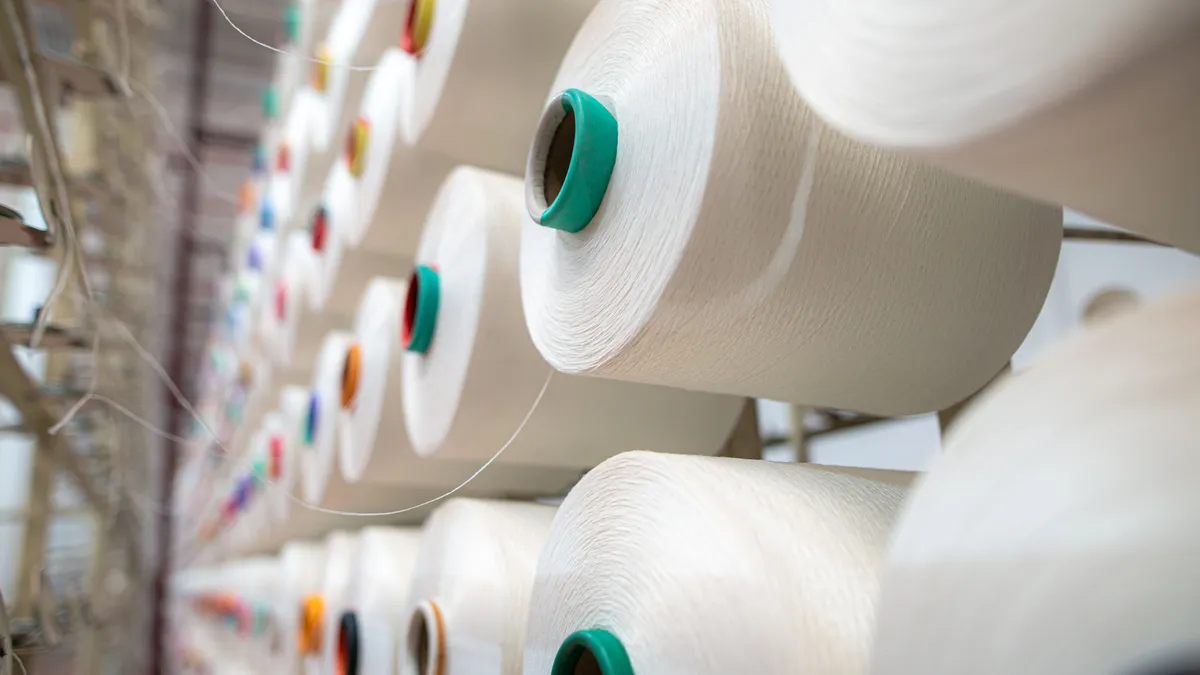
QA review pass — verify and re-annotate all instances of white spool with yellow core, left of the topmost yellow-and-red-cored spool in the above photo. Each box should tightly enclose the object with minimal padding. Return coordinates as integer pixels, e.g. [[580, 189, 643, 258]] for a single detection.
[[313, 0, 408, 151]]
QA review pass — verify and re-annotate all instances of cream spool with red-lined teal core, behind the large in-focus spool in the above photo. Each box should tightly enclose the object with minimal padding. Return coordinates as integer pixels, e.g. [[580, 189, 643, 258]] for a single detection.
[[402, 167, 744, 468]]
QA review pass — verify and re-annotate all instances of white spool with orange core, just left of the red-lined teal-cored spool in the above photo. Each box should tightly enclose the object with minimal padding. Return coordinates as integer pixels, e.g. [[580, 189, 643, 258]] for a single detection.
[[338, 279, 578, 496]]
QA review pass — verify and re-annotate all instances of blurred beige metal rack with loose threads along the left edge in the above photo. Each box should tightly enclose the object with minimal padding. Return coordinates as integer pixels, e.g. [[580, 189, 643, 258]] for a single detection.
[[0, 0, 164, 674]]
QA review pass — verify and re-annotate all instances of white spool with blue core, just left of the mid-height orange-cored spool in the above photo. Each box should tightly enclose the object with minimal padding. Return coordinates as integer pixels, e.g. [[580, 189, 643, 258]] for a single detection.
[[300, 333, 442, 514]]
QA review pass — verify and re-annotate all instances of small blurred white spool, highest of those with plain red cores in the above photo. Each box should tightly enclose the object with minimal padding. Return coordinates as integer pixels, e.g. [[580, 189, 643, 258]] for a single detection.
[[269, 89, 334, 232]]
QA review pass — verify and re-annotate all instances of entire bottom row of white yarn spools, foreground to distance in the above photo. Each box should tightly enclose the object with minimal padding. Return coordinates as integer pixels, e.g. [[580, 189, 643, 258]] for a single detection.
[[174, 278, 1200, 675]]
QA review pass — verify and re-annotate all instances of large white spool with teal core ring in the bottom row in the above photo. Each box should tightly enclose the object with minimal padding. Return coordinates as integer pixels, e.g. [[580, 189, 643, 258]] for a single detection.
[[524, 452, 904, 675]]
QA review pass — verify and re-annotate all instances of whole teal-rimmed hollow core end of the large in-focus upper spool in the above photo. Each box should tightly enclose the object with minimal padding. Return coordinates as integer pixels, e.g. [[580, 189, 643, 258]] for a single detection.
[[526, 89, 618, 233]]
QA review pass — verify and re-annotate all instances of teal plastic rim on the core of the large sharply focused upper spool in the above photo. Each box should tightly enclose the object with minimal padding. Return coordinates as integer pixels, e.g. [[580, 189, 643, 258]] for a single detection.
[[534, 89, 618, 232]]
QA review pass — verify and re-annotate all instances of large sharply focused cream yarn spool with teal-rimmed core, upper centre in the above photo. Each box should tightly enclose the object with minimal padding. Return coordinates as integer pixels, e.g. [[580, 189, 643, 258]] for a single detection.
[[521, 0, 1062, 416]]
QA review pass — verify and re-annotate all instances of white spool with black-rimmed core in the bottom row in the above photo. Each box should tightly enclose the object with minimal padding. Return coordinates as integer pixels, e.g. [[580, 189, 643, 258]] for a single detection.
[[338, 527, 421, 675]]
